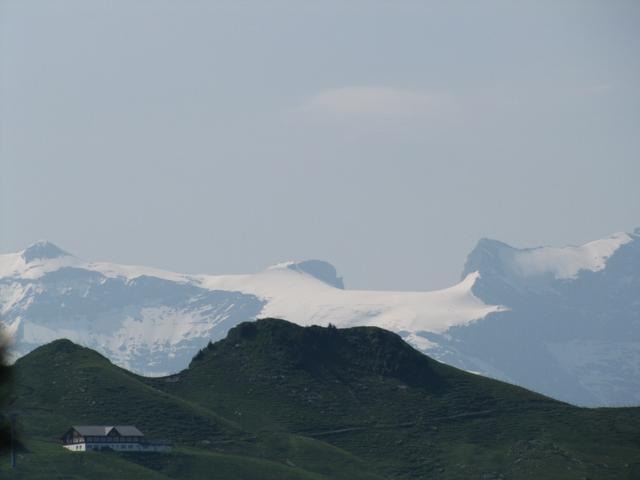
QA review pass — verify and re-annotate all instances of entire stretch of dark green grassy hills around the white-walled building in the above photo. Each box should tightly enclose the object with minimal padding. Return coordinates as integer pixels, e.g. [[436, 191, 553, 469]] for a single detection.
[[0, 319, 640, 479]]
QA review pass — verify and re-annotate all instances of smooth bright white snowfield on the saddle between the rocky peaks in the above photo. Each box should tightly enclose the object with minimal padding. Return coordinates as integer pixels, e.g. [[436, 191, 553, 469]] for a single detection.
[[199, 262, 504, 332]]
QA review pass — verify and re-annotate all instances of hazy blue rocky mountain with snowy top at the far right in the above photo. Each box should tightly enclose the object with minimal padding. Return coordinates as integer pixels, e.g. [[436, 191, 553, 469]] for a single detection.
[[427, 229, 640, 406]]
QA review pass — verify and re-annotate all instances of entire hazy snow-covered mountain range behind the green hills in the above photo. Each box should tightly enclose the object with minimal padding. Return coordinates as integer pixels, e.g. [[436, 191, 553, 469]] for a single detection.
[[0, 229, 640, 406]]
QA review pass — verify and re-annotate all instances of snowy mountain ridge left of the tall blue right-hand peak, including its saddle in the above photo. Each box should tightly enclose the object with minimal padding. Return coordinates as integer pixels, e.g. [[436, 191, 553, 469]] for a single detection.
[[0, 242, 500, 375]]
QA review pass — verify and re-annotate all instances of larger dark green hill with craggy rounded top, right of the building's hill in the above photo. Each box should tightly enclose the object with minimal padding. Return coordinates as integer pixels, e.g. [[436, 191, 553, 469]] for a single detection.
[[149, 320, 640, 479]]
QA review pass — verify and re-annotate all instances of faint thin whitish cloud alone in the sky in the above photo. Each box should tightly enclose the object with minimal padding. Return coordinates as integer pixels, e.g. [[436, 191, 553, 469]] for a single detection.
[[297, 86, 451, 117]]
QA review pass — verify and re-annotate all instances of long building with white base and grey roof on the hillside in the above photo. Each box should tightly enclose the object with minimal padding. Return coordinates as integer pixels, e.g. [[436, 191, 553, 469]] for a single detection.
[[62, 425, 171, 452]]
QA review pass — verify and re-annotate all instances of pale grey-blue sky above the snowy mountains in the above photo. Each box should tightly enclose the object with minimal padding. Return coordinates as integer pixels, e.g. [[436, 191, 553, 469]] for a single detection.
[[0, 0, 640, 290]]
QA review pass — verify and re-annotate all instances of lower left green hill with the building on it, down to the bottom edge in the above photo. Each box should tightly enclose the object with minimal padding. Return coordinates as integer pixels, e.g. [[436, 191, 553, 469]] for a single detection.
[[0, 340, 379, 480]]
